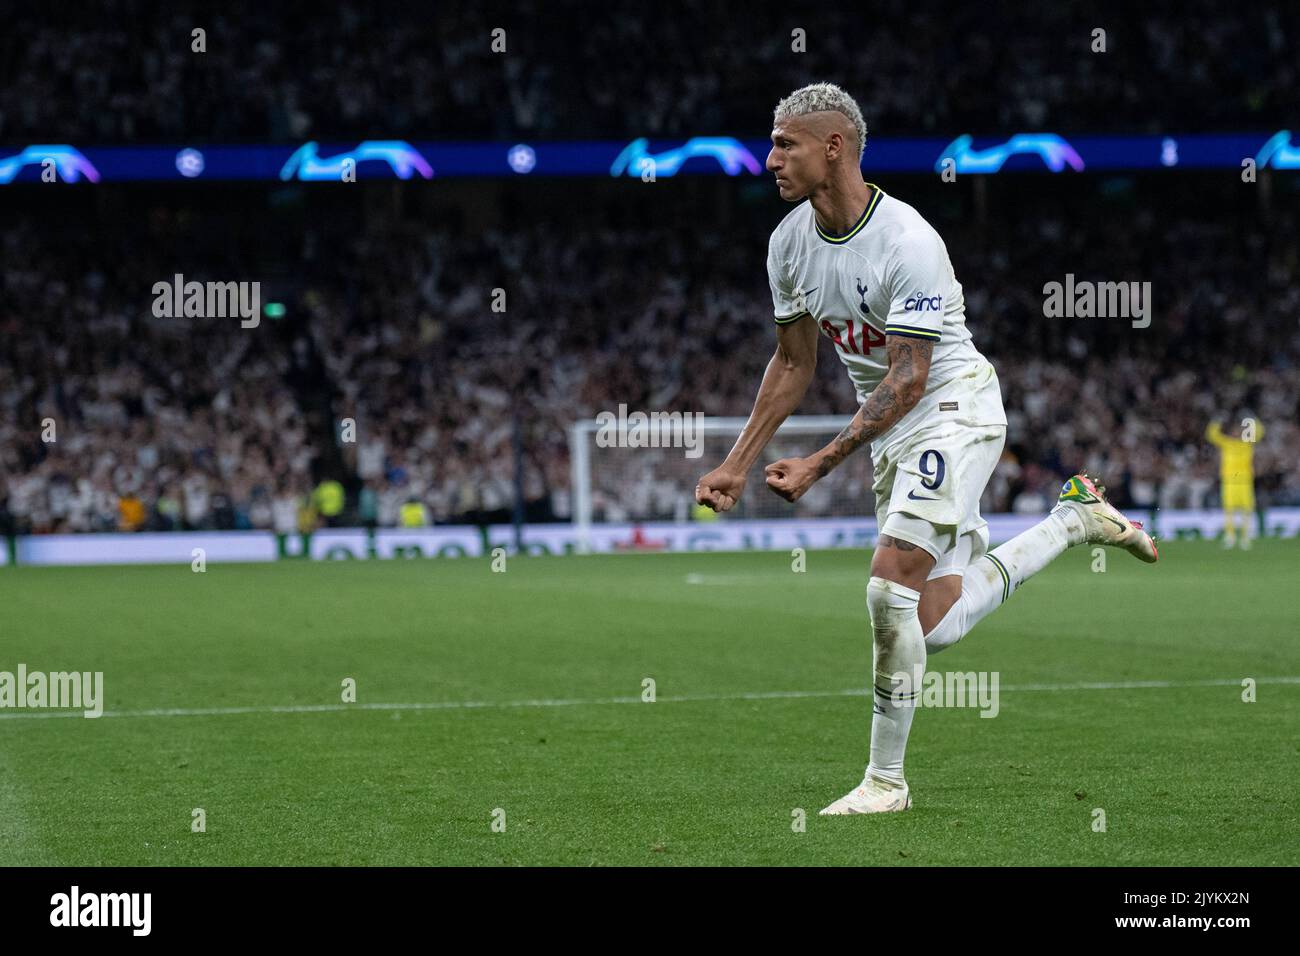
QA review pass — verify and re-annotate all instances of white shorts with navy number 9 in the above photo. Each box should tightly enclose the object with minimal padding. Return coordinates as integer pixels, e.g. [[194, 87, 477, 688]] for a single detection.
[[872, 421, 1006, 579]]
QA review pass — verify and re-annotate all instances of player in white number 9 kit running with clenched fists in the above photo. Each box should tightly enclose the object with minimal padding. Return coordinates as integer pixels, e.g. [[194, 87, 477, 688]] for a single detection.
[[696, 83, 1157, 814]]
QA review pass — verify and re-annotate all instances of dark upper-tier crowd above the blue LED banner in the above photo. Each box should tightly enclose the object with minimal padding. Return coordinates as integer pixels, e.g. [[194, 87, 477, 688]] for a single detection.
[[0, 0, 1300, 144]]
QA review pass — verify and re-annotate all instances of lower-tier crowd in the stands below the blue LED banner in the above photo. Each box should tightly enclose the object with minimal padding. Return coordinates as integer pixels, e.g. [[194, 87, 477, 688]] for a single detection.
[[0, 184, 1300, 533]]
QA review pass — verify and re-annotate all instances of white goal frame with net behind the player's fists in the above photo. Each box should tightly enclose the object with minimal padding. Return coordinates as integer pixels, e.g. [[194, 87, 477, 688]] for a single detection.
[[569, 415, 875, 551]]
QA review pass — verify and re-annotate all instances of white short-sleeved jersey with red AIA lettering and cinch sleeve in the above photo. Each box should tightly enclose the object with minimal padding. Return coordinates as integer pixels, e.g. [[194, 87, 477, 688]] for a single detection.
[[767, 183, 1006, 442]]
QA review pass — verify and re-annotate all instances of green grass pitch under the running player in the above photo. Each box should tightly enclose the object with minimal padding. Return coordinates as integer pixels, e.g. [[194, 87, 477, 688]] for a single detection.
[[0, 541, 1300, 865]]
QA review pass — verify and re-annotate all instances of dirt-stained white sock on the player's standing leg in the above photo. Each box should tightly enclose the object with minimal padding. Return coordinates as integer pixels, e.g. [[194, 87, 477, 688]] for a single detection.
[[867, 578, 926, 787]]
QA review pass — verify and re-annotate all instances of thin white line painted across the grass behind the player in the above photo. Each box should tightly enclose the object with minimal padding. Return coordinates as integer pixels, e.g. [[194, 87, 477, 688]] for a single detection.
[[0, 676, 1300, 721]]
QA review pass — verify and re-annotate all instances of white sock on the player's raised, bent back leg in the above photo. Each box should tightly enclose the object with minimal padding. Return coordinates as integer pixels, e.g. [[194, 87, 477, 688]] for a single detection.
[[926, 507, 1087, 654]]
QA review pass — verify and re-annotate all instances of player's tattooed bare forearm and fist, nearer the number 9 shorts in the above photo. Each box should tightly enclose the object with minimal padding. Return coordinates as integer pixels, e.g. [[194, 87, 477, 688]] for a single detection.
[[766, 336, 935, 501]]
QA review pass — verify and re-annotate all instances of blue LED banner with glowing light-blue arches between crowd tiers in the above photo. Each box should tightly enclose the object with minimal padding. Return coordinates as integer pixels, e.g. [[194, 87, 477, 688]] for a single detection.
[[0, 130, 1300, 185]]
